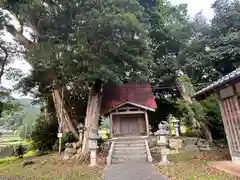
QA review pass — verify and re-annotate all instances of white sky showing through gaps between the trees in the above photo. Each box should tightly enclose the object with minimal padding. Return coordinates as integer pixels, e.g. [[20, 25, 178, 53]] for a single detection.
[[2, 0, 215, 98]]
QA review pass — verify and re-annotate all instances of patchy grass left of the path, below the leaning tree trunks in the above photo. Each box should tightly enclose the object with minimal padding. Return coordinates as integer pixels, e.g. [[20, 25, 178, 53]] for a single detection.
[[0, 154, 102, 180]]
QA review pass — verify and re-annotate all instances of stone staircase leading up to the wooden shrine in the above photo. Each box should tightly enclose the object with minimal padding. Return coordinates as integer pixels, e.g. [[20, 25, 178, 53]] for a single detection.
[[109, 137, 151, 164]]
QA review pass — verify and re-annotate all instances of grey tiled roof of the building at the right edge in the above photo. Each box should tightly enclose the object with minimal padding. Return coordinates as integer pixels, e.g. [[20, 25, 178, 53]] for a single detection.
[[194, 68, 240, 96]]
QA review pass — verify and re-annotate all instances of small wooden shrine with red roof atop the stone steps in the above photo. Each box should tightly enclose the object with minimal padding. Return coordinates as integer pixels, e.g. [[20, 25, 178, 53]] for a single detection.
[[101, 83, 157, 137]]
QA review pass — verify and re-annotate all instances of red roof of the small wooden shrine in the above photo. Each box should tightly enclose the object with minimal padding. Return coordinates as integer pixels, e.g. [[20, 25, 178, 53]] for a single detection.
[[101, 83, 157, 113]]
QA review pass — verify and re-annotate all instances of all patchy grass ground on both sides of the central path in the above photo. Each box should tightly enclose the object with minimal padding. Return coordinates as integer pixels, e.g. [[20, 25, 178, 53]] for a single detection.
[[0, 146, 236, 180]]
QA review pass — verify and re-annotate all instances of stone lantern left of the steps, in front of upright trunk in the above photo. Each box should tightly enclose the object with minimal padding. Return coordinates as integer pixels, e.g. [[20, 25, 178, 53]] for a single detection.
[[88, 130, 100, 166]]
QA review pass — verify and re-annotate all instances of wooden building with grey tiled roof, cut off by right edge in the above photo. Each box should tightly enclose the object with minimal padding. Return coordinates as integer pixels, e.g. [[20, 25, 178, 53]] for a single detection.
[[195, 68, 240, 164]]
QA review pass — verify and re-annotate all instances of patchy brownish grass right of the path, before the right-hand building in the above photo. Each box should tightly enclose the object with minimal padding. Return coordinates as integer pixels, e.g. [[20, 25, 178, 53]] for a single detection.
[[159, 150, 240, 180]]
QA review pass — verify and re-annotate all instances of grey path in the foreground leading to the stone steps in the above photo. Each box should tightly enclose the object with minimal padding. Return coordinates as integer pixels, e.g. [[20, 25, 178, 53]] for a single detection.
[[103, 162, 168, 180]]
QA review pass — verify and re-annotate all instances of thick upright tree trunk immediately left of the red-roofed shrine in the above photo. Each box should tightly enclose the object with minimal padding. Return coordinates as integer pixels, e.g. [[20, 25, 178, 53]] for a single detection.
[[82, 81, 102, 154]]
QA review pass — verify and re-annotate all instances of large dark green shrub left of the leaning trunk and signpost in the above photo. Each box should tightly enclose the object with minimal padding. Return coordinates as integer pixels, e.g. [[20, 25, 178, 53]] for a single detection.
[[31, 117, 58, 152]]
